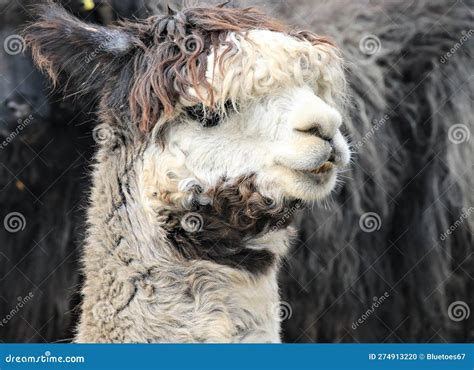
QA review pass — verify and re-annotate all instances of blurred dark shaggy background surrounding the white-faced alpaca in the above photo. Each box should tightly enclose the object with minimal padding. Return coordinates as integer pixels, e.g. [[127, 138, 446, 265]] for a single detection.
[[0, 0, 474, 343]]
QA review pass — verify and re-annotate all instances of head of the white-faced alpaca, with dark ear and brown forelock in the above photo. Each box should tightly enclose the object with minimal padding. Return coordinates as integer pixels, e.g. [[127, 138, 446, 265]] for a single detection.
[[26, 5, 349, 214]]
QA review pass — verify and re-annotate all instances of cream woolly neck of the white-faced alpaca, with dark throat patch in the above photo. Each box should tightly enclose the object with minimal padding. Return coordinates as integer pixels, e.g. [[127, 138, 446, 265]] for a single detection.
[[77, 140, 289, 342]]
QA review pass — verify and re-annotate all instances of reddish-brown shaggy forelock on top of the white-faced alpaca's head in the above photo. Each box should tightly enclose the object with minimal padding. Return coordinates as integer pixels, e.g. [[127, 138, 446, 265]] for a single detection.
[[122, 7, 331, 132]]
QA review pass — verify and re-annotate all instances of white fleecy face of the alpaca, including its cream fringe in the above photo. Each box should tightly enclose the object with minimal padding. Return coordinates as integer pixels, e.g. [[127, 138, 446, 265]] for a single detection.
[[145, 31, 350, 205]]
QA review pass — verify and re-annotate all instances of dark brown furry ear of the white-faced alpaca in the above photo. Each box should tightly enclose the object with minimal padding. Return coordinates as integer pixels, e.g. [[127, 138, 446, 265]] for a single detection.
[[24, 3, 136, 93]]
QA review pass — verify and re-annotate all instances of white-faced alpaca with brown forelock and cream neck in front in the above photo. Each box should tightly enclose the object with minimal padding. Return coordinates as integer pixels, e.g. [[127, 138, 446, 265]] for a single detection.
[[26, 5, 350, 342]]
